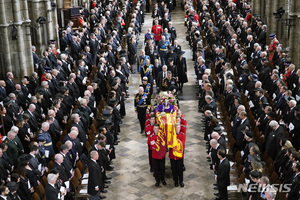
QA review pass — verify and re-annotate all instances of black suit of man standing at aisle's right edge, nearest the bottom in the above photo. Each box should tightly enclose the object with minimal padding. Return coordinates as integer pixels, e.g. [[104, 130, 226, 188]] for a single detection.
[[217, 158, 230, 200]]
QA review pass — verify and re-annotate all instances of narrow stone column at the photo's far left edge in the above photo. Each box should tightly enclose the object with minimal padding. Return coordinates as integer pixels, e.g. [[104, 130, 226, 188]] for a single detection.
[[0, 0, 12, 74]]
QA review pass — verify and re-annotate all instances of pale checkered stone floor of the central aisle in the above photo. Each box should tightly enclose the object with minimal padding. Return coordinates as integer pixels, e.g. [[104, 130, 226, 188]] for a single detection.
[[105, 3, 214, 200]]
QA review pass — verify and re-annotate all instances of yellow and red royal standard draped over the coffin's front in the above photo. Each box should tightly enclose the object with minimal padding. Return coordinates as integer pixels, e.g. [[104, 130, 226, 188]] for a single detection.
[[156, 112, 183, 158]]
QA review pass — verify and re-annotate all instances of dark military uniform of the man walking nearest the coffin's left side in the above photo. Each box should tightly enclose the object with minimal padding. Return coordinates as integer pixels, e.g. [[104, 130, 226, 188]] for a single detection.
[[134, 93, 151, 133]]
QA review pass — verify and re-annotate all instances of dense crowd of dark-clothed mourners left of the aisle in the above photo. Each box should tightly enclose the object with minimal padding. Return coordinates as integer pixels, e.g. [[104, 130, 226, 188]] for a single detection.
[[0, 0, 145, 200]]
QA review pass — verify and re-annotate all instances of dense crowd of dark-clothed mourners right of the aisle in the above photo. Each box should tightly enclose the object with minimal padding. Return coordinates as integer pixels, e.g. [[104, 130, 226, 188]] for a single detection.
[[184, 0, 300, 200]]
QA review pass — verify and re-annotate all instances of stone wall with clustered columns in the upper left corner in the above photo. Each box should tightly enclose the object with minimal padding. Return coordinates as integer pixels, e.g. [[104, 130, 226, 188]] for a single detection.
[[0, 0, 59, 80]]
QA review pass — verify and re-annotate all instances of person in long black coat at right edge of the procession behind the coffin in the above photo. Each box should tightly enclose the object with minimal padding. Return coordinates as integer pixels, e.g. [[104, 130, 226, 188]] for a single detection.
[[176, 51, 188, 93]]
